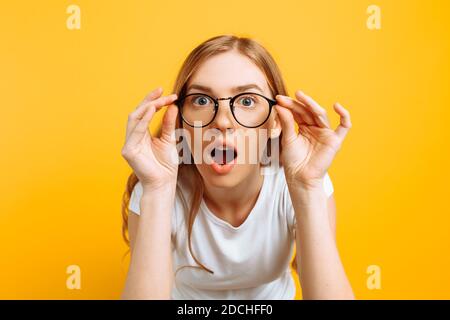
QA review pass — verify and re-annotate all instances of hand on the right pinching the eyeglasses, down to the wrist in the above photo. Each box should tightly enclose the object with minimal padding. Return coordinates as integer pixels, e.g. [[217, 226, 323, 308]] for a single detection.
[[275, 91, 351, 188]]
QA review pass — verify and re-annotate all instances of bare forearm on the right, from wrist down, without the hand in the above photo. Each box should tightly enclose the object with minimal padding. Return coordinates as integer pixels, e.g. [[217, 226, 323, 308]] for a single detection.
[[289, 182, 354, 299]]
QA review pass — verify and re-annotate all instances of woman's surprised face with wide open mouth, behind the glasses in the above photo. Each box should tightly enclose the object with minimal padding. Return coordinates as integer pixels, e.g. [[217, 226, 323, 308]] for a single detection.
[[183, 51, 281, 188]]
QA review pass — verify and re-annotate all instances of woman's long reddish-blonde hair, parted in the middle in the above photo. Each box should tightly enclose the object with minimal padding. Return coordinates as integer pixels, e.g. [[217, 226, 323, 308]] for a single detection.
[[122, 35, 297, 273]]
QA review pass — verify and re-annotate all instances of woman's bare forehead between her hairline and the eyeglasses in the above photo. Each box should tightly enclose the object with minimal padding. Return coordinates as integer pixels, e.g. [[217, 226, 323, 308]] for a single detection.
[[187, 51, 270, 96]]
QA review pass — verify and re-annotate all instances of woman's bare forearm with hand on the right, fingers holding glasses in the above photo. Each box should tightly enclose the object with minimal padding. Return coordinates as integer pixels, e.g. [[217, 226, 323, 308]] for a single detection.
[[276, 91, 354, 299]]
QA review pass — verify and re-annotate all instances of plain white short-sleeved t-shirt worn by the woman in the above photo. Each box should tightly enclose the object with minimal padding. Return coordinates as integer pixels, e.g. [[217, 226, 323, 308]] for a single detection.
[[129, 167, 333, 299]]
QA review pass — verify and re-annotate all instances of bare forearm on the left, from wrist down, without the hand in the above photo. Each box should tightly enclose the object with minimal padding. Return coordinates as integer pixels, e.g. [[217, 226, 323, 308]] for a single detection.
[[122, 186, 175, 299]]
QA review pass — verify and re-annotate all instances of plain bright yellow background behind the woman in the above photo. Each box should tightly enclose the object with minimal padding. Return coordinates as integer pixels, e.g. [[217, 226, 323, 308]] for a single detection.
[[0, 0, 450, 299]]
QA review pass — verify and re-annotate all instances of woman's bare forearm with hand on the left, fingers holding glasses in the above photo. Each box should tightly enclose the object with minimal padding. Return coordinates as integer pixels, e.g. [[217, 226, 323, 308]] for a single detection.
[[122, 87, 178, 299]]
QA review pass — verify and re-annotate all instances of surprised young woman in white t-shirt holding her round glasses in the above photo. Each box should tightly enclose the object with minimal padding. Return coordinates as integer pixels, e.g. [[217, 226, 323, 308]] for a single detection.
[[122, 35, 354, 299]]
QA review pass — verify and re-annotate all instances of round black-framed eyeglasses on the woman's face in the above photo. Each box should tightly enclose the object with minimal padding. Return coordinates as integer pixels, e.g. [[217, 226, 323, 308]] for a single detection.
[[175, 92, 277, 128]]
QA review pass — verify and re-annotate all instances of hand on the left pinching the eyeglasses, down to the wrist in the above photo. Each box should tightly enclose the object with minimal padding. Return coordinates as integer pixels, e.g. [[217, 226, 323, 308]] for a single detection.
[[122, 87, 178, 190]]
